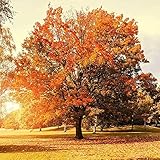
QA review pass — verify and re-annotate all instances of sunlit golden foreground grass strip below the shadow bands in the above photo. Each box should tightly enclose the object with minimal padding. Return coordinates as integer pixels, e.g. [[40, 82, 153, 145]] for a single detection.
[[0, 142, 160, 160]]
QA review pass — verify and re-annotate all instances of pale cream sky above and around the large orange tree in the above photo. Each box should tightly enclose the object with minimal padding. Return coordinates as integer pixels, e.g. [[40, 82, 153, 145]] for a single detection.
[[8, 0, 160, 81]]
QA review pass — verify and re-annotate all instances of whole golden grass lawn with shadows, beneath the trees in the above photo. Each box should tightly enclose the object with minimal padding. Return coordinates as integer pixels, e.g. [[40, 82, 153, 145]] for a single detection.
[[0, 127, 160, 160]]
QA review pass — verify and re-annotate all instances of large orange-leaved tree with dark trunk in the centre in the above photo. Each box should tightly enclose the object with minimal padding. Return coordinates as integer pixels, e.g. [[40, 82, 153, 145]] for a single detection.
[[14, 7, 158, 139]]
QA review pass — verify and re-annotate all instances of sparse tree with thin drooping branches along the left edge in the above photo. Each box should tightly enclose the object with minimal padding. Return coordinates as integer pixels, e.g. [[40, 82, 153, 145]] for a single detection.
[[0, 0, 15, 114]]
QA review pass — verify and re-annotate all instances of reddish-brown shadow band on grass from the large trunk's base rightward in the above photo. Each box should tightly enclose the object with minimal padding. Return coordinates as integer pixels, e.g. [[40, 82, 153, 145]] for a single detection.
[[18, 135, 160, 146]]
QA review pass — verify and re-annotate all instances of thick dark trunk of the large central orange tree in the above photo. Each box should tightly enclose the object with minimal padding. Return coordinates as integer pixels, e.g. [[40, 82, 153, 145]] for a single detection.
[[75, 116, 83, 139]]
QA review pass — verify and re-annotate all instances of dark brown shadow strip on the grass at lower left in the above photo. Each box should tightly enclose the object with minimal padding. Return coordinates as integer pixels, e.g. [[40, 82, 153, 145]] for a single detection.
[[0, 145, 55, 153]]
